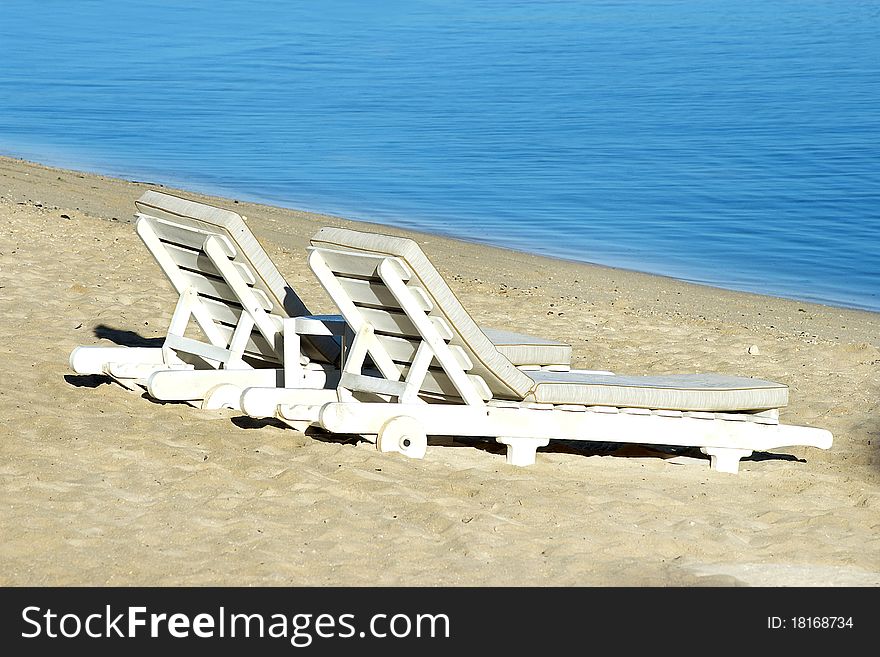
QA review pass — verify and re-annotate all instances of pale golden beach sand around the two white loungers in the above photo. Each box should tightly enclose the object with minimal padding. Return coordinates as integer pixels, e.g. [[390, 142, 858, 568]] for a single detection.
[[0, 158, 880, 586]]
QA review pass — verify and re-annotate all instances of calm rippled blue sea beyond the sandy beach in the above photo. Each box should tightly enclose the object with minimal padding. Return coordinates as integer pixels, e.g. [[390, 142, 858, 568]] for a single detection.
[[0, 0, 880, 311]]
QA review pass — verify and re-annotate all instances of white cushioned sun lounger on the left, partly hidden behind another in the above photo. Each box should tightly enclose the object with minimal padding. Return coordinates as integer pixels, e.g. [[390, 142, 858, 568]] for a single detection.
[[70, 191, 571, 408]]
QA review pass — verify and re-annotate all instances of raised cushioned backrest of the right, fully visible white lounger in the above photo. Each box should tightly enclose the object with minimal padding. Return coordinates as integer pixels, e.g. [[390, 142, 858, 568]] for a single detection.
[[309, 228, 532, 400]]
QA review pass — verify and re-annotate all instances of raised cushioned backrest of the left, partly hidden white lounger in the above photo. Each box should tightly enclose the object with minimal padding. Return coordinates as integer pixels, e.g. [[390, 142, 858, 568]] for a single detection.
[[135, 190, 338, 363]]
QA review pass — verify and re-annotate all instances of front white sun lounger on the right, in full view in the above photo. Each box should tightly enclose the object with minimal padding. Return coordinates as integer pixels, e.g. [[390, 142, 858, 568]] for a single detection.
[[266, 228, 832, 472]]
